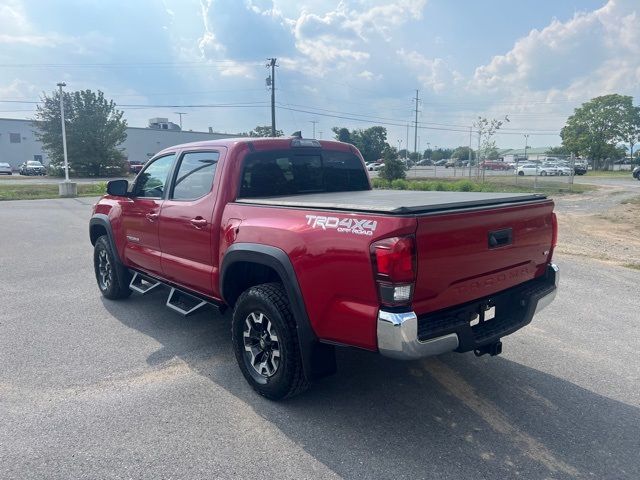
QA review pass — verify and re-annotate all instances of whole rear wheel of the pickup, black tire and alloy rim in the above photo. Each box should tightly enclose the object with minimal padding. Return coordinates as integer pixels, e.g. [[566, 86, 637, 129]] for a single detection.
[[231, 283, 309, 400]]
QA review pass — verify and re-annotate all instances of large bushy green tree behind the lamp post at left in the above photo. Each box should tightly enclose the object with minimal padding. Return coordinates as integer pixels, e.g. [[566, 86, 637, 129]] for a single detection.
[[33, 90, 127, 176]]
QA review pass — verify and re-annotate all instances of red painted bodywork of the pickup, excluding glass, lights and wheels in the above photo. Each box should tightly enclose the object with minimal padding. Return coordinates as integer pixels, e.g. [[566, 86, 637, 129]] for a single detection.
[[95, 139, 553, 350]]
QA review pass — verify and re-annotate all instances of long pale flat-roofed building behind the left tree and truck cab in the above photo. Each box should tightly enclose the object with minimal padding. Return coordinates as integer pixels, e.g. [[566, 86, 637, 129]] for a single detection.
[[0, 118, 238, 170]]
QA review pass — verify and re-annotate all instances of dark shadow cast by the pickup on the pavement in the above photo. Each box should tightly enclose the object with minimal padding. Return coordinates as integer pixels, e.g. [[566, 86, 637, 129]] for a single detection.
[[103, 292, 640, 479]]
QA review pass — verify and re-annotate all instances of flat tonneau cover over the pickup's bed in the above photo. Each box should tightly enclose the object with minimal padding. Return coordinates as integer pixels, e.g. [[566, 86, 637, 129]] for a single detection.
[[237, 190, 546, 215]]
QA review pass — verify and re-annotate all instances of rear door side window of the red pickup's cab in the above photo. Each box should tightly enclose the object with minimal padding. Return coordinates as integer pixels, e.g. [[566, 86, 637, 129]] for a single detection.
[[171, 152, 220, 200]]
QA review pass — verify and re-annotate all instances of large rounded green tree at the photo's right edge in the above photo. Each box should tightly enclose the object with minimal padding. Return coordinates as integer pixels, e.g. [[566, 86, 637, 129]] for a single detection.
[[560, 94, 636, 168]]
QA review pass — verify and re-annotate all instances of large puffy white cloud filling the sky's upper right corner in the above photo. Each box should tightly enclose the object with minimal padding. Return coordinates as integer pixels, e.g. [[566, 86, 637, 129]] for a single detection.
[[469, 0, 640, 97]]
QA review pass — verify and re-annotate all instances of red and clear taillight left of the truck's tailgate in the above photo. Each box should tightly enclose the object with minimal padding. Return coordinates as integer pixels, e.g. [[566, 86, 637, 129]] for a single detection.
[[371, 237, 417, 307]]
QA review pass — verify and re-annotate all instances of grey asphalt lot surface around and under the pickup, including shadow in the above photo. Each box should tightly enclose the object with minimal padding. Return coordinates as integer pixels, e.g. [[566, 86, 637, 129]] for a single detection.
[[0, 197, 640, 479]]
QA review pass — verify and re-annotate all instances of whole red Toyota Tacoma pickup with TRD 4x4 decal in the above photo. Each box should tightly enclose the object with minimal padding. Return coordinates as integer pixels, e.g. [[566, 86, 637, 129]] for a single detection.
[[89, 138, 559, 399]]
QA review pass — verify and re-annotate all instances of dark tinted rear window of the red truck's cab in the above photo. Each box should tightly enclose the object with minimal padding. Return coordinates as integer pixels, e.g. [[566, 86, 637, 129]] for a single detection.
[[239, 150, 370, 198]]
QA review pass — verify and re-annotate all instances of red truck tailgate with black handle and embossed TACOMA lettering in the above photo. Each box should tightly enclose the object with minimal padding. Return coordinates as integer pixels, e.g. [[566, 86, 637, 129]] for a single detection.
[[414, 200, 553, 315]]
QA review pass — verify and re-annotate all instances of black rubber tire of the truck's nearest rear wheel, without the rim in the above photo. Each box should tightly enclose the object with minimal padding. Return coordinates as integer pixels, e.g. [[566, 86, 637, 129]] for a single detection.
[[231, 283, 310, 400]]
